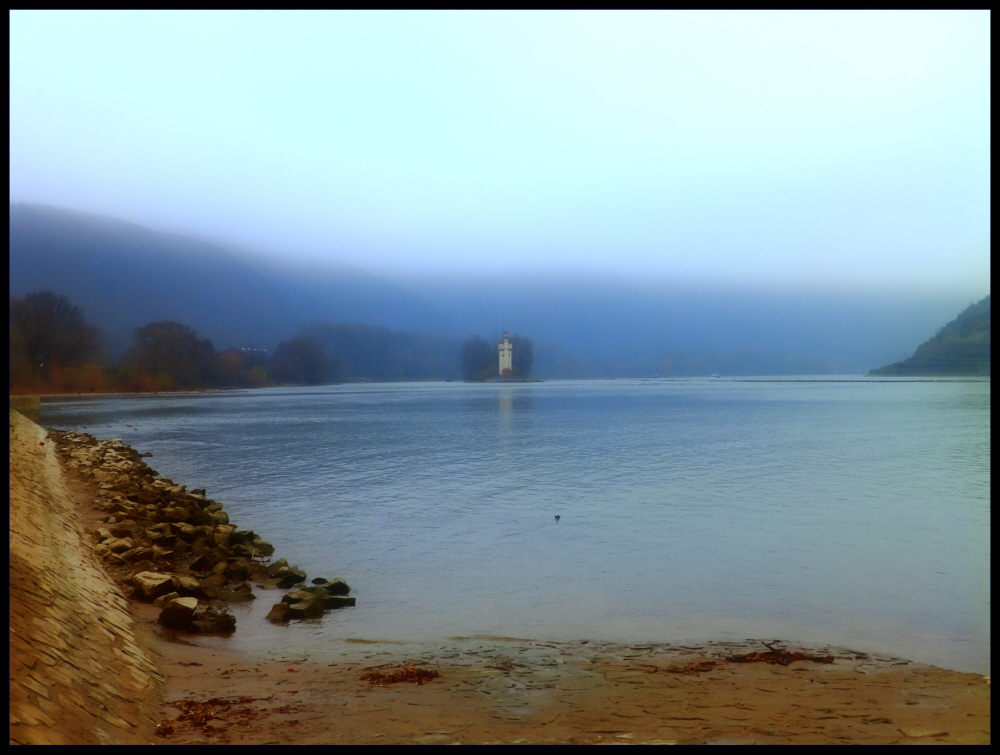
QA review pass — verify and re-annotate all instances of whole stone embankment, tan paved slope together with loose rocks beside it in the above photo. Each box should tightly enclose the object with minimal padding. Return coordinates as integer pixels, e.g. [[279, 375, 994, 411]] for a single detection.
[[10, 410, 354, 744]]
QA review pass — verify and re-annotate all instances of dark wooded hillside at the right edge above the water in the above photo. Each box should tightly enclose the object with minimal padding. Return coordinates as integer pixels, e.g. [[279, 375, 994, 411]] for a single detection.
[[869, 295, 990, 376]]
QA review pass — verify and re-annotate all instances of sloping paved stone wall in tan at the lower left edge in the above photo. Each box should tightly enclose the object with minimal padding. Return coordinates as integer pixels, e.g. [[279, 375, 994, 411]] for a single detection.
[[9, 411, 163, 744]]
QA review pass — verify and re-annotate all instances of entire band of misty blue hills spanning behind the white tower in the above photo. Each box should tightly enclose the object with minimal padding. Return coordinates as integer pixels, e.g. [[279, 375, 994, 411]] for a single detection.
[[9, 203, 988, 378]]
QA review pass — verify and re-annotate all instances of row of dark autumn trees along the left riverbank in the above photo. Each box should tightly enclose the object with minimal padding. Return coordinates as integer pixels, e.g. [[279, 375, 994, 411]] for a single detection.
[[9, 291, 458, 393]]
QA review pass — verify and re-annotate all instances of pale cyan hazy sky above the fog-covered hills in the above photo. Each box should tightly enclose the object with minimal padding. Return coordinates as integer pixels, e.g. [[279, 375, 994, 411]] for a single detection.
[[10, 11, 990, 296]]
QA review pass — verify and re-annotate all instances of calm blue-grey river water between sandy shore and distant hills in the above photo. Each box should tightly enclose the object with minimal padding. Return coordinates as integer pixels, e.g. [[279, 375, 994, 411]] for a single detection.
[[42, 378, 990, 674]]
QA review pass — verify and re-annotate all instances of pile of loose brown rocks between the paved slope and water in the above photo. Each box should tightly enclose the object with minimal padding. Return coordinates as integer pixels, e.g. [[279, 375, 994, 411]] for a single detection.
[[51, 430, 354, 633]]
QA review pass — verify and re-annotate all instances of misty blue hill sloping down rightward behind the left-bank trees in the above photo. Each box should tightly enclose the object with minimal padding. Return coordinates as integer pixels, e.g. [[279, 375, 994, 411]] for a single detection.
[[10, 203, 451, 356]]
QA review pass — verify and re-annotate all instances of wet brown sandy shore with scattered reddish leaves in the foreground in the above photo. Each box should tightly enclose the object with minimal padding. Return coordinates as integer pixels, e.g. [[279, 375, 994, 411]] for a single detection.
[[152, 638, 990, 744]]
